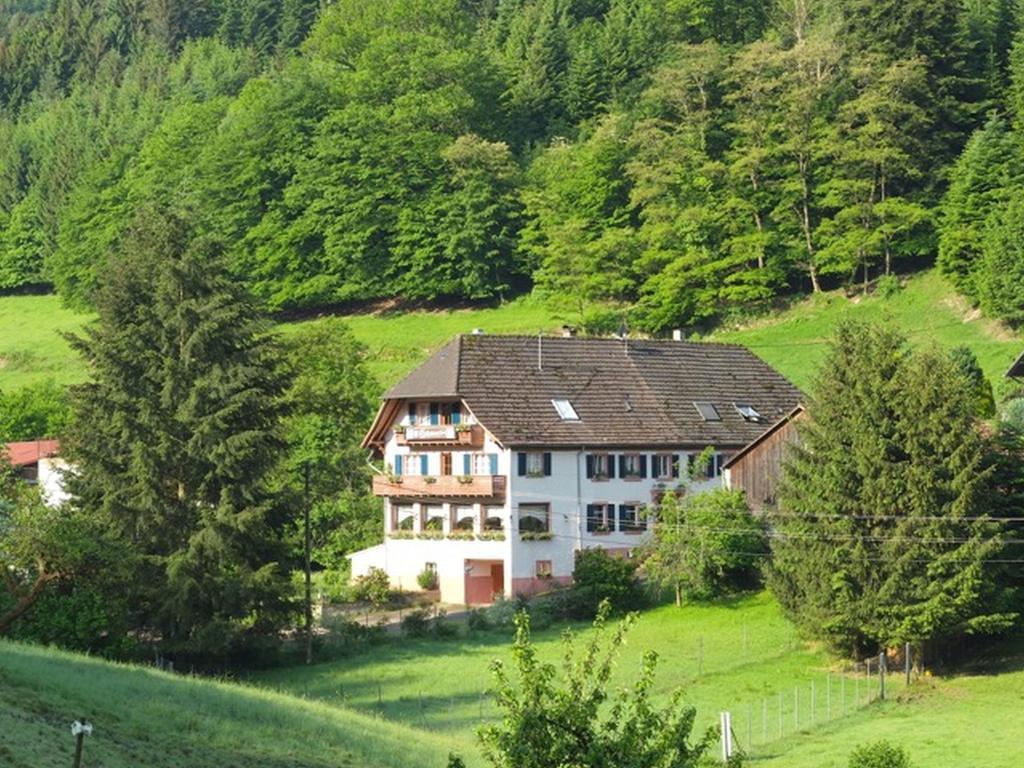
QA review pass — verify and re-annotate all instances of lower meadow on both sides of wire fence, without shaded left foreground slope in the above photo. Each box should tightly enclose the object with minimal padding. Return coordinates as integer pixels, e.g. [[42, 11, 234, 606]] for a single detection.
[[251, 594, 1024, 768]]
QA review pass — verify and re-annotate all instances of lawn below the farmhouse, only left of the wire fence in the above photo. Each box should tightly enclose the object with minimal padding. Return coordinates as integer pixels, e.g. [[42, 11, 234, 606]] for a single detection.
[[254, 594, 902, 756]]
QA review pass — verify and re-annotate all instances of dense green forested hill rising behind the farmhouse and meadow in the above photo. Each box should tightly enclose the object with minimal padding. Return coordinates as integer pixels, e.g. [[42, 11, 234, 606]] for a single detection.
[[0, 0, 1024, 333]]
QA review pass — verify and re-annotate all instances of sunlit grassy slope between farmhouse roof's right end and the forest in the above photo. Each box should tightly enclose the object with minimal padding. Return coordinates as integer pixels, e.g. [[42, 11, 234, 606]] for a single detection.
[[711, 269, 1024, 391]]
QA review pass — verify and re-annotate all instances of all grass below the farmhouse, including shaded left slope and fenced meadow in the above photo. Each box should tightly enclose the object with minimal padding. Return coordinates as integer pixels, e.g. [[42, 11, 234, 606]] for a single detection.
[[0, 594, 1024, 768]]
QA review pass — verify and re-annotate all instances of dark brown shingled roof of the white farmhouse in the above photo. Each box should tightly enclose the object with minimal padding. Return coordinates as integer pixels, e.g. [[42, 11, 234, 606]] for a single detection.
[[377, 335, 803, 447]]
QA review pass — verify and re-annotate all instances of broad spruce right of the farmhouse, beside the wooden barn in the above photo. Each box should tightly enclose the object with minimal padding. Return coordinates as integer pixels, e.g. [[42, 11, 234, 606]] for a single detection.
[[769, 324, 1017, 654]]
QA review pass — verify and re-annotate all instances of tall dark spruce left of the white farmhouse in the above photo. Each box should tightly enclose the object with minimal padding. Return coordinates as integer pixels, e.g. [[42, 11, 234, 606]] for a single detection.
[[68, 205, 290, 655]]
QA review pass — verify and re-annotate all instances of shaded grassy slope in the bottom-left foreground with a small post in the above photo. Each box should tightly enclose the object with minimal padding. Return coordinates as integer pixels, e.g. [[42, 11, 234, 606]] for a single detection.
[[0, 641, 456, 768]]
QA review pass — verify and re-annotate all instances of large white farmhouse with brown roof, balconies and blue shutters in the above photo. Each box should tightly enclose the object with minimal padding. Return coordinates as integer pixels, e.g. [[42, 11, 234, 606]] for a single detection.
[[352, 333, 802, 604]]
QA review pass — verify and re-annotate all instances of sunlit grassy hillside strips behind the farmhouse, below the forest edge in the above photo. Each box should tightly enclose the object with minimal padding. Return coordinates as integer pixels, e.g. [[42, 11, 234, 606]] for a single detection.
[[0, 270, 1024, 397]]
